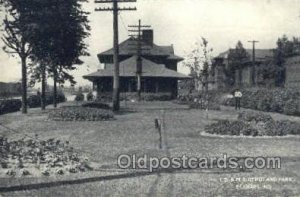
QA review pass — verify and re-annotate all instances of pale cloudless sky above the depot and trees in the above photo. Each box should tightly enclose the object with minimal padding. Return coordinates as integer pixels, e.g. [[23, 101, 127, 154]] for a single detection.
[[0, 0, 300, 85]]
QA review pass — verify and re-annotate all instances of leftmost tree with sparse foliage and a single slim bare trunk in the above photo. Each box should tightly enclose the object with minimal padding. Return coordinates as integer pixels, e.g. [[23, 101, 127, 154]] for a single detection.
[[0, 0, 32, 113]]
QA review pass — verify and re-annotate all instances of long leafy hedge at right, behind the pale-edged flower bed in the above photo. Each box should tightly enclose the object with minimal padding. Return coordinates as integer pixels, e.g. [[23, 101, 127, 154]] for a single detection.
[[223, 88, 300, 116]]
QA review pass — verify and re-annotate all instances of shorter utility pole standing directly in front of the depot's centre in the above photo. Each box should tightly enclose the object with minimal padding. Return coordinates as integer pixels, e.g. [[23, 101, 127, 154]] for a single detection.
[[128, 20, 151, 101]]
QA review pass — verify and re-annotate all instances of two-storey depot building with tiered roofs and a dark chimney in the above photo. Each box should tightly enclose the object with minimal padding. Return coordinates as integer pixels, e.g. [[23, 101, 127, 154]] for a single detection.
[[83, 30, 190, 98]]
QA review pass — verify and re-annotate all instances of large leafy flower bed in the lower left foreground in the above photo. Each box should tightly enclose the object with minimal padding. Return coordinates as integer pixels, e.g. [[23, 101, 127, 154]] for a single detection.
[[0, 136, 91, 177]]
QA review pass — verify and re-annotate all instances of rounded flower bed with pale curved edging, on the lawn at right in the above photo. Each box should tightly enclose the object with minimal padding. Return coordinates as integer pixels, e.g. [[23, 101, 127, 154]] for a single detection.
[[205, 112, 300, 136]]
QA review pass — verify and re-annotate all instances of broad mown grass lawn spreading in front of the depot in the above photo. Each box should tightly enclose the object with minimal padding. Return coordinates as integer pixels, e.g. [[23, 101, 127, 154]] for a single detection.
[[0, 102, 300, 196]]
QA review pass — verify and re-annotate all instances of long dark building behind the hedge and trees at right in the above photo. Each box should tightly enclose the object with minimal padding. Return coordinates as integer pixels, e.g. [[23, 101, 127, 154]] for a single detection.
[[212, 49, 300, 89]]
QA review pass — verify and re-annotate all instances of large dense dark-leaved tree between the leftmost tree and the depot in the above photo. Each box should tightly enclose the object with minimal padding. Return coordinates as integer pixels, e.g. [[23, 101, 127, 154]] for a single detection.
[[30, 0, 90, 108]]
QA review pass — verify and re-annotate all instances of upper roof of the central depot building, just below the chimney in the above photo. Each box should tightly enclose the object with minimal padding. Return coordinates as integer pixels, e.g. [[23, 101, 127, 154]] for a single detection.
[[98, 37, 183, 61]]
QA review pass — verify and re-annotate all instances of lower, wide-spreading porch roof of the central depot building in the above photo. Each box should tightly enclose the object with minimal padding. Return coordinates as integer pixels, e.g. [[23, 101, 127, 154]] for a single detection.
[[83, 56, 190, 80]]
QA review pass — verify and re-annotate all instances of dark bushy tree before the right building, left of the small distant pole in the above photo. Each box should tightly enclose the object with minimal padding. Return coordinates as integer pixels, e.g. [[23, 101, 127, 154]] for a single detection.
[[226, 41, 249, 86]]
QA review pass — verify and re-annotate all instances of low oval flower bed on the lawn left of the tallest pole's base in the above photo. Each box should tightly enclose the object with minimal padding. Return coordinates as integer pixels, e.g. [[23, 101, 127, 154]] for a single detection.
[[49, 106, 114, 121]]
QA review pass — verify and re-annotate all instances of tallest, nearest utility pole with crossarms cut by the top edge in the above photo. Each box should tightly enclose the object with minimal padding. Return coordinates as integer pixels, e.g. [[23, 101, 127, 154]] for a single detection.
[[95, 0, 136, 111]]
